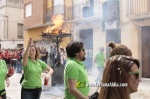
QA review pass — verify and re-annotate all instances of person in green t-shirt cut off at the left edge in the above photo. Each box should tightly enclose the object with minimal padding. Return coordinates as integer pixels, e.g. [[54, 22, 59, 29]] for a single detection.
[[0, 59, 13, 99]]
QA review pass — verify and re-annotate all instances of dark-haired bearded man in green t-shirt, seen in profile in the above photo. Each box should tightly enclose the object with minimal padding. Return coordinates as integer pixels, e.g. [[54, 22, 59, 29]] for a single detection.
[[64, 41, 90, 99]]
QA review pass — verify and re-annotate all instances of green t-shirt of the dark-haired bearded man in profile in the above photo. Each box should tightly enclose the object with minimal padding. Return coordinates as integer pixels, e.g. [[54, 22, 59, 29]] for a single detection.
[[64, 59, 90, 99]]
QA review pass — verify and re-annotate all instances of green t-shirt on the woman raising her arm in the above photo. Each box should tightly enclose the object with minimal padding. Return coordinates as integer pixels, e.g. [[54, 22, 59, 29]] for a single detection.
[[21, 58, 47, 89]]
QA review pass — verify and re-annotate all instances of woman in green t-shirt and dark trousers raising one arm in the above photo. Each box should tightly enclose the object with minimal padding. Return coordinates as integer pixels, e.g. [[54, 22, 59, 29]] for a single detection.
[[21, 38, 53, 99]]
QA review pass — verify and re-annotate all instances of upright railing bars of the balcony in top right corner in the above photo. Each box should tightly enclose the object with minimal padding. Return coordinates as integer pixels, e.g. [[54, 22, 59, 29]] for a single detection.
[[126, 0, 150, 16]]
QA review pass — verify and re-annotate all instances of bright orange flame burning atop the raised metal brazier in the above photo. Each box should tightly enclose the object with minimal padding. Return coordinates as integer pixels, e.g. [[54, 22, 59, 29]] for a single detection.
[[44, 14, 64, 34]]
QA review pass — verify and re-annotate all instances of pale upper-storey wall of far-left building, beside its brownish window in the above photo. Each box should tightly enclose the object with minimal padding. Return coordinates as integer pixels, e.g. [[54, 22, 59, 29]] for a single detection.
[[0, 7, 24, 39]]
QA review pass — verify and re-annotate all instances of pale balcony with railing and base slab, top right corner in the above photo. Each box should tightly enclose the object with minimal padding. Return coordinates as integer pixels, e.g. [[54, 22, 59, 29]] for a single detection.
[[126, 0, 150, 19]]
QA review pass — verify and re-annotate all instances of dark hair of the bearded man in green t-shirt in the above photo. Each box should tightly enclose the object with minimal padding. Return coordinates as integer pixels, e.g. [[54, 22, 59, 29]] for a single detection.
[[66, 41, 83, 58]]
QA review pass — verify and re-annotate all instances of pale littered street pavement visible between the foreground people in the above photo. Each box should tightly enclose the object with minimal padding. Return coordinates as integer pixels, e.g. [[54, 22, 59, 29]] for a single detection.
[[6, 73, 150, 99]]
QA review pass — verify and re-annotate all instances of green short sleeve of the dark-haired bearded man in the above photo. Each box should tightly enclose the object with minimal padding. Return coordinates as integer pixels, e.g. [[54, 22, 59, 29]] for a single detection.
[[66, 63, 79, 79]]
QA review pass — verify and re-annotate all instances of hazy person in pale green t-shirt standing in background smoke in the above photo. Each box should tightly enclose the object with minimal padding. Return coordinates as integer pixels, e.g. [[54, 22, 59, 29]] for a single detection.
[[94, 47, 105, 81]]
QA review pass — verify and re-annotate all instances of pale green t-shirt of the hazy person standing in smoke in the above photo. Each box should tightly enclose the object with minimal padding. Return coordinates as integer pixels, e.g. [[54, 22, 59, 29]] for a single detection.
[[95, 52, 105, 67]]
